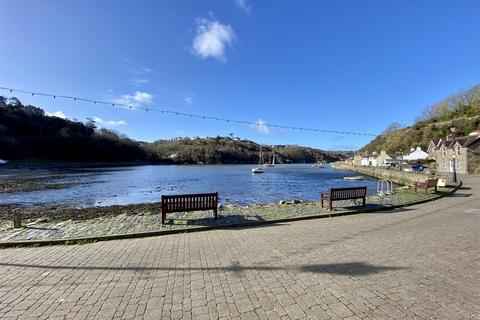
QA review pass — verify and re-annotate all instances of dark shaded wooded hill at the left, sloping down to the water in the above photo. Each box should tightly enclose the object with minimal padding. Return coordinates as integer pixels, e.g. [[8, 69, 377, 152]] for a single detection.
[[0, 96, 151, 162]]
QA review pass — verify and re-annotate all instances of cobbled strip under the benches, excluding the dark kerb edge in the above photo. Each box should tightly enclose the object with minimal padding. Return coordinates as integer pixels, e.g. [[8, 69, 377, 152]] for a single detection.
[[0, 188, 451, 244]]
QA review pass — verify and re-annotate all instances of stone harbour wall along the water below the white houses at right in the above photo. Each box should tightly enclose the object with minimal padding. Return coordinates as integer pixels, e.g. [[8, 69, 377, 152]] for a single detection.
[[332, 162, 428, 185]]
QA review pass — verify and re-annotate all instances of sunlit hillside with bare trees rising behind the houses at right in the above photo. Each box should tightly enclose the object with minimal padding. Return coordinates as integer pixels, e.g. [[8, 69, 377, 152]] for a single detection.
[[360, 85, 480, 153]]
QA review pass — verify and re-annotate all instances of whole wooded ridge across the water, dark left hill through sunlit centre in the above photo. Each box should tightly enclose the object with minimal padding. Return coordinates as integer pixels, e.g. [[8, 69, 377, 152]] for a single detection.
[[0, 96, 346, 164]]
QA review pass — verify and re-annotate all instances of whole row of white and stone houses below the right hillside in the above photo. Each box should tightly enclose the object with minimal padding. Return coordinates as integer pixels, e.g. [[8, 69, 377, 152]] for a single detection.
[[350, 130, 480, 174]]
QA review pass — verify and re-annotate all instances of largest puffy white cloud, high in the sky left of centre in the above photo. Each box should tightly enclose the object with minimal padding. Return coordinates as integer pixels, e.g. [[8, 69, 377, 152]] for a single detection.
[[192, 19, 235, 61]]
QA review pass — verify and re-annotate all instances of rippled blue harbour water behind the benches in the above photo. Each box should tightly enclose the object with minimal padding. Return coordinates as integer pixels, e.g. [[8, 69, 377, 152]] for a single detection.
[[0, 164, 382, 207]]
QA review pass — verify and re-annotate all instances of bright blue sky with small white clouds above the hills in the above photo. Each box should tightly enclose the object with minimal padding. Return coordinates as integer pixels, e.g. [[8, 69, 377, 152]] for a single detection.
[[0, 0, 480, 149]]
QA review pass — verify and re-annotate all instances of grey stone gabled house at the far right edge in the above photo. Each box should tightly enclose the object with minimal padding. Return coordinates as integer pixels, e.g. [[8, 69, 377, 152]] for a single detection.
[[427, 130, 480, 175]]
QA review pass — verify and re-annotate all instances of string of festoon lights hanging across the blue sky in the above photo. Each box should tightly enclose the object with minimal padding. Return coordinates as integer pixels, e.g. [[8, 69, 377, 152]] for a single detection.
[[0, 86, 377, 136]]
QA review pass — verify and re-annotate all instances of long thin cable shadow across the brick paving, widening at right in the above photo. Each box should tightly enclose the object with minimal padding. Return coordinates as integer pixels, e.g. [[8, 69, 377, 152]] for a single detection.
[[0, 262, 406, 276]]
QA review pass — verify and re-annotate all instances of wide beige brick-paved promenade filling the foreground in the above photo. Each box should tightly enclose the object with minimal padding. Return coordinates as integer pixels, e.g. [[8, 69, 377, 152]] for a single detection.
[[0, 177, 480, 320]]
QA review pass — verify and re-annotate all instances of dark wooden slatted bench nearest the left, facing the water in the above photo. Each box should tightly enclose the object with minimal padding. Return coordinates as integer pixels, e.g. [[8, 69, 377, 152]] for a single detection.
[[162, 192, 218, 224]]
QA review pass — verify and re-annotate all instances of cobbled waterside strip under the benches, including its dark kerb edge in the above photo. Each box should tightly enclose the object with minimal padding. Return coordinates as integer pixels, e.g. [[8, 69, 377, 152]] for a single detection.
[[0, 184, 461, 247]]
